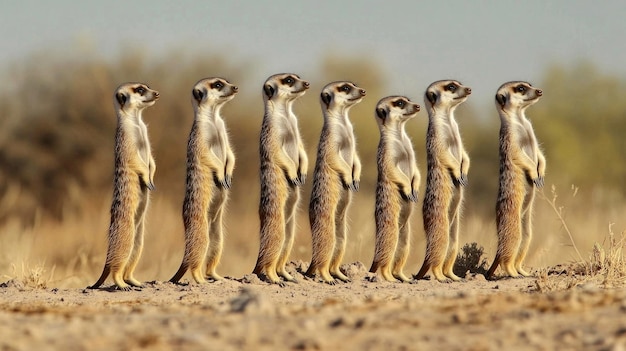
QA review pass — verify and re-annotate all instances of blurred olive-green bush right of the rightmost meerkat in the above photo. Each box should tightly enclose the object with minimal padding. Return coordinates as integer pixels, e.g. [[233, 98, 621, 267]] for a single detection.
[[529, 62, 626, 201]]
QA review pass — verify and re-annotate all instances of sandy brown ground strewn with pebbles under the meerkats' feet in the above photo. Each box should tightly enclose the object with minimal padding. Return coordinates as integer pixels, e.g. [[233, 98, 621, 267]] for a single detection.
[[0, 262, 626, 350]]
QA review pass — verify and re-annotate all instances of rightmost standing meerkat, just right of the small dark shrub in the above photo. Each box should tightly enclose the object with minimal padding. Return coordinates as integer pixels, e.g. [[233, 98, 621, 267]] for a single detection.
[[487, 81, 546, 278]]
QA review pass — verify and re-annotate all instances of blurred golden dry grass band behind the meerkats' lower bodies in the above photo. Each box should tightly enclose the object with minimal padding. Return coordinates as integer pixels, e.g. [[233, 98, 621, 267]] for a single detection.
[[0, 185, 626, 291]]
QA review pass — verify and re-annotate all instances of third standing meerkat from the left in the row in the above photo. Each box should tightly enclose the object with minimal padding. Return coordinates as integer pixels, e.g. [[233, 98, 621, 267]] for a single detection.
[[253, 73, 309, 284]]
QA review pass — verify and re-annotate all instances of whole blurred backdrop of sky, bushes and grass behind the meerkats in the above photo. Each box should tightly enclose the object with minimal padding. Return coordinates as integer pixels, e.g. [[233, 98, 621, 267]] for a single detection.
[[0, 0, 626, 287]]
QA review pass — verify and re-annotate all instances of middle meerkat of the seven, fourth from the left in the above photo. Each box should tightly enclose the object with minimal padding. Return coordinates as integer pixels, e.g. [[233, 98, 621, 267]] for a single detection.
[[306, 82, 365, 284]]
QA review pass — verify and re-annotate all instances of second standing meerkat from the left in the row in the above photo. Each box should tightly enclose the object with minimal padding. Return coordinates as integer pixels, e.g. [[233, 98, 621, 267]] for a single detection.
[[170, 78, 237, 283]]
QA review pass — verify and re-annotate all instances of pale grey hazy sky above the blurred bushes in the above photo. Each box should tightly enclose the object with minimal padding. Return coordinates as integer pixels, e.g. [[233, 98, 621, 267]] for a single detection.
[[0, 0, 626, 103]]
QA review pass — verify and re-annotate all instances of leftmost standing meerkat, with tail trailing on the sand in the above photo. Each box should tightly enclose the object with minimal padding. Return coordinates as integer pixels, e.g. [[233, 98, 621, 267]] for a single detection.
[[90, 83, 159, 290]]
